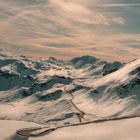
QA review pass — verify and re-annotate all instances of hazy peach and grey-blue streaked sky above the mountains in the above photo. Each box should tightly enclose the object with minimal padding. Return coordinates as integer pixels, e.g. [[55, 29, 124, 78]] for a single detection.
[[0, 0, 140, 61]]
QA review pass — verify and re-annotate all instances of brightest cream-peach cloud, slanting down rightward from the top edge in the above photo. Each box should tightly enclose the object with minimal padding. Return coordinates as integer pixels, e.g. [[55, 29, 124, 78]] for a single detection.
[[50, 0, 109, 25]]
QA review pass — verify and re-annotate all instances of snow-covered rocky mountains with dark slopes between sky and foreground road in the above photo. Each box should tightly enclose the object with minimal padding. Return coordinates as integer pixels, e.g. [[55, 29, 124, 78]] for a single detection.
[[0, 51, 140, 125]]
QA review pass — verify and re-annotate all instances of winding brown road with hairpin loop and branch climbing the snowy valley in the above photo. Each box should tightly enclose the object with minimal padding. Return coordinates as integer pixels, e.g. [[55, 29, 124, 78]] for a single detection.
[[16, 87, 140, 139]]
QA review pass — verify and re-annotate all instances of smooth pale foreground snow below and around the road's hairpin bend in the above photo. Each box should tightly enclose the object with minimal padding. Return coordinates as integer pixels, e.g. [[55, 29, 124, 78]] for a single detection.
[[0, 118, 140, 140]]
